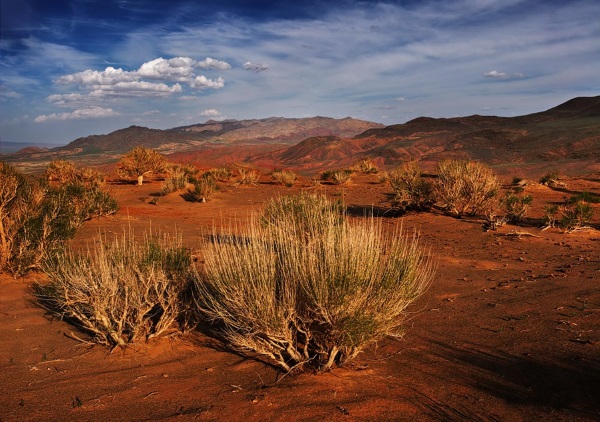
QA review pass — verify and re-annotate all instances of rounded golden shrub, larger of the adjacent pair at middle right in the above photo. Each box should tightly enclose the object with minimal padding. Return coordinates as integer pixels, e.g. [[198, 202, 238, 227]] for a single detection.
[[434, 160, 500, 217]]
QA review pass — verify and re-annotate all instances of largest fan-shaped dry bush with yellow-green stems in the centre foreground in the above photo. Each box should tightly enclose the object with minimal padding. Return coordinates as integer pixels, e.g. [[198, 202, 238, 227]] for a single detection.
[[196, 193, 433, 371]]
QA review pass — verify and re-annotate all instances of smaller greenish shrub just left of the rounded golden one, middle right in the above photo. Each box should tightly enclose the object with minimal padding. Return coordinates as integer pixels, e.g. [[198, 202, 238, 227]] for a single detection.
[[387, 160, 433, 211]]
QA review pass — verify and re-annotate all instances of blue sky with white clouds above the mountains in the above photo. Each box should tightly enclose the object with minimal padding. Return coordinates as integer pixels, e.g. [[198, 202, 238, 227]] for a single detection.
[[0, 0, 600, 144]]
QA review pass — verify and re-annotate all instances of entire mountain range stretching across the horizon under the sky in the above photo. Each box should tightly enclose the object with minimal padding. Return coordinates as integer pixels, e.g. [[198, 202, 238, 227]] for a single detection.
[[2, 96, 600, 174]]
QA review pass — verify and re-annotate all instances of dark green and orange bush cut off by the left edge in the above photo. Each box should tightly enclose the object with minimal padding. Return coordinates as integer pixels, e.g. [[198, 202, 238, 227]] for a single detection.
[[0, 163, 118, 276]]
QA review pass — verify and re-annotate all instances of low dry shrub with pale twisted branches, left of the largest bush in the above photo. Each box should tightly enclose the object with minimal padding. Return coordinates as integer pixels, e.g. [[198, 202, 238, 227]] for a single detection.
[[35, 233, 191, 348]]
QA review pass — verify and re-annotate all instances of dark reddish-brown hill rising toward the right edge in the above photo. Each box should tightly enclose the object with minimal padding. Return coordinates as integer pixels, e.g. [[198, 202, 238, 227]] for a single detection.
[[254, 96, 600, 175]]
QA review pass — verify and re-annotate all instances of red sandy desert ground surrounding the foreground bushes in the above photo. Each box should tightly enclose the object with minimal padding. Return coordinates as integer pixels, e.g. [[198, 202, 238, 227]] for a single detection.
[[0, 176, 600, 421]]
